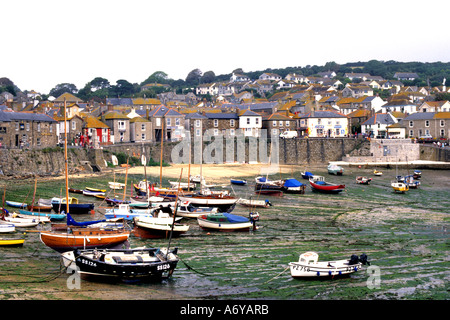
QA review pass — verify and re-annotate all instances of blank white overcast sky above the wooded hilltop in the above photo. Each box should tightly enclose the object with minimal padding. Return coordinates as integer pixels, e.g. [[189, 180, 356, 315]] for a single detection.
[[0, 0, 450, 93]]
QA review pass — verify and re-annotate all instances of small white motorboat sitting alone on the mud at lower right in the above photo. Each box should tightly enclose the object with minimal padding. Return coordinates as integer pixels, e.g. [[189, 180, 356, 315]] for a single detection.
[[289, 251, 370, 278]]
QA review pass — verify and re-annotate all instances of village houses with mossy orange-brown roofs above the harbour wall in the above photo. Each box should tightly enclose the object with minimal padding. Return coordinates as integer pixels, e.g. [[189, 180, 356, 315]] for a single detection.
[[0, 70, 450, 148]]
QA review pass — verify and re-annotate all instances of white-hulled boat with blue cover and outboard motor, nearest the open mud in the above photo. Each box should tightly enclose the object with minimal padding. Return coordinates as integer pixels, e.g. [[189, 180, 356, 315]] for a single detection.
[[197, 212, 259, 231]]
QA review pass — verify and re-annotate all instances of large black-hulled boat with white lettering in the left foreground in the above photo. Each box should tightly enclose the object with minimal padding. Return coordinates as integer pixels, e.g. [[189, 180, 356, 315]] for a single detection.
[[61, 248, 179, 281]]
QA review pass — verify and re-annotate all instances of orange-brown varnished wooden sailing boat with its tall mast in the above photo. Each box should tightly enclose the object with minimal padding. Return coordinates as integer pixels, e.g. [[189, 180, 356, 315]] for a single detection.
[[39, 99, 130, 252]]
